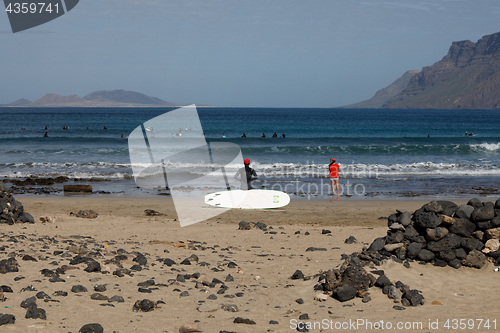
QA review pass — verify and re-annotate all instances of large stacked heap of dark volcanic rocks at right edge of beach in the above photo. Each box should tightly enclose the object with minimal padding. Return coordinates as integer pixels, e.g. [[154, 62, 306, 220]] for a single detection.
[[368, 199, 500, 268]]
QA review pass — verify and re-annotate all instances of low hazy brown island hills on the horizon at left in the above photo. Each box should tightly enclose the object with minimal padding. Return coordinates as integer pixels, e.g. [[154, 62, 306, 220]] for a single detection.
[[3, 90, 193, 107]]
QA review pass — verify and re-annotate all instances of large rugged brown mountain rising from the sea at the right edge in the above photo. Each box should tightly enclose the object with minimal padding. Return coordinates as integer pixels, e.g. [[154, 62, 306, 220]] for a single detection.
[[383, 32, 500, 109]]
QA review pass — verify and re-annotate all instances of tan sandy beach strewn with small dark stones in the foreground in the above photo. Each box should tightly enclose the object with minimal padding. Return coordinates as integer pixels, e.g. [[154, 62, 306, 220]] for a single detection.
[[0, 197, 500, 333]]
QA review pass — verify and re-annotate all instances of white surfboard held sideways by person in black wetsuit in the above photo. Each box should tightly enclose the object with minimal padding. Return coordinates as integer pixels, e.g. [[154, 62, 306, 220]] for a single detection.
[[205, 190, 290, 209]]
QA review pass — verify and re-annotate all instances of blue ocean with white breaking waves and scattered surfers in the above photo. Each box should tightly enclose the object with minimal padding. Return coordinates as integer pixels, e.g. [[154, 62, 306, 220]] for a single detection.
[[0, 107, 500, 199]]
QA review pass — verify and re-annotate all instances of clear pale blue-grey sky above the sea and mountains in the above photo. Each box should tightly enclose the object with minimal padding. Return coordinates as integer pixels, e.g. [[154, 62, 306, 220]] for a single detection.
[[0, 0, 500, 107]]
